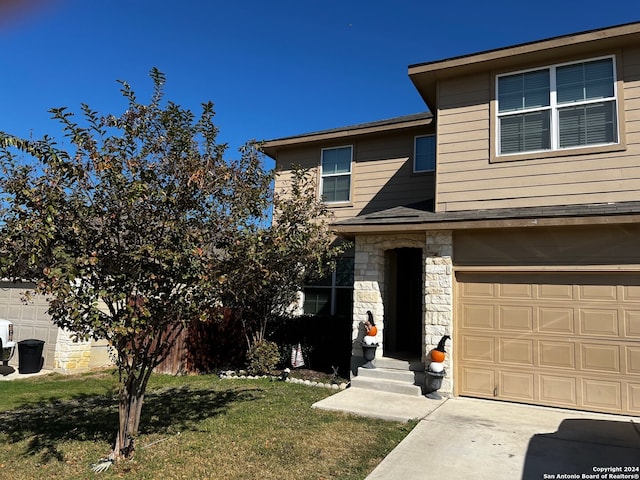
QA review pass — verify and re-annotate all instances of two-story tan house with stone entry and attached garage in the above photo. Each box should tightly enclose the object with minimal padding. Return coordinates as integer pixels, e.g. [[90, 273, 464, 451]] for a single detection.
[[264, 23, 640, 415]]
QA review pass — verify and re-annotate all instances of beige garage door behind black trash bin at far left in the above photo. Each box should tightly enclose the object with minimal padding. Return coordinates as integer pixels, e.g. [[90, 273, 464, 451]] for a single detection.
[[0, 282, 58, 369]]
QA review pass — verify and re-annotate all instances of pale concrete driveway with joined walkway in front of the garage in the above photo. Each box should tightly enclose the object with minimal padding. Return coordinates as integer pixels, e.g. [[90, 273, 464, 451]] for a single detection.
[[314, 389, 640, 480]]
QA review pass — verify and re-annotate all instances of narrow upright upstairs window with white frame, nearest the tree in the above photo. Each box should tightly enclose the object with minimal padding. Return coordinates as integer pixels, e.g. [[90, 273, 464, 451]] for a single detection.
[[321, 146, 352, 202]]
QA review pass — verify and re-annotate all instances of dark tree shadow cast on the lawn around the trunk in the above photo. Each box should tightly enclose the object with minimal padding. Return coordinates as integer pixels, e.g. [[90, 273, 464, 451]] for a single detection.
[[0, 387, 262, 462]]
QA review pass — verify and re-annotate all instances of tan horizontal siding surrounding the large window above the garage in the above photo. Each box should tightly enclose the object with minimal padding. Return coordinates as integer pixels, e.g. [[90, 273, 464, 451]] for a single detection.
[[436, 47, 640, 211]]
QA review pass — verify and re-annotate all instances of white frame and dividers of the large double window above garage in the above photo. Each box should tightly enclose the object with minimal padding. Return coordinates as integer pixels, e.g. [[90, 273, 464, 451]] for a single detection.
[[495, 55, 620, 157]]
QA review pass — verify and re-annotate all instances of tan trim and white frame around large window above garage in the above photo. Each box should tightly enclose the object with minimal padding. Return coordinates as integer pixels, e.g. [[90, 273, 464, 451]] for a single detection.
[[490, 52, 626, 163]]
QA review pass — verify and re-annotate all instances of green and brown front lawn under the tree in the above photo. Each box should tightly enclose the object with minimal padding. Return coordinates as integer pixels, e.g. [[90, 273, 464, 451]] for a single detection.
[[0, 372, 414, 480]]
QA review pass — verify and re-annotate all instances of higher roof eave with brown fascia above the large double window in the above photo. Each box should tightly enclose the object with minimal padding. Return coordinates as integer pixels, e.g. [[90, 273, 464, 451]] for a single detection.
[[409, 22, 640, 111]]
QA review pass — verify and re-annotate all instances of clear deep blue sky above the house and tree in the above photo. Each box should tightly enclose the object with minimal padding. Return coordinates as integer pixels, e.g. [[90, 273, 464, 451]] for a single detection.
[[0, 0, 640, 167]]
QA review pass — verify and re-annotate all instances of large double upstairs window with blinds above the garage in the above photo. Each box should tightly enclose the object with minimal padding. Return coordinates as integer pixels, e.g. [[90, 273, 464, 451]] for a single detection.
[[496, 57, 618, 155]]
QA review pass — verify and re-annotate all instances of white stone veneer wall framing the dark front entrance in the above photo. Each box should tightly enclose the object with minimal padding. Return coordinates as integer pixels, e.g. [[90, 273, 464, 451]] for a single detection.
[[352, 231, 453, 394]]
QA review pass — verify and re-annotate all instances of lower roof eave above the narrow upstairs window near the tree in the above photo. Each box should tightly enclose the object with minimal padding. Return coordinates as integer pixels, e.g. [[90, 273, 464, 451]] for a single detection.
[[262, 112, 433, 159]]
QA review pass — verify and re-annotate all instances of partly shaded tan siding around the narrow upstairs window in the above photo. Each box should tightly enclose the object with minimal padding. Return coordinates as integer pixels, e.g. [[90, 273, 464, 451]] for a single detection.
[[276, 128, 434, 221]]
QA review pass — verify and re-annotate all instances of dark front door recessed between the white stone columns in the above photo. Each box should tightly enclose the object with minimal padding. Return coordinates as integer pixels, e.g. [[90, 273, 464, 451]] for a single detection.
[[384, 248, 423, 359]]
